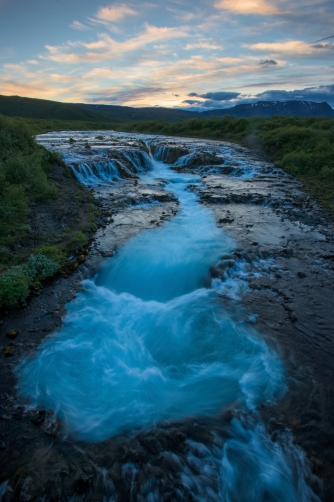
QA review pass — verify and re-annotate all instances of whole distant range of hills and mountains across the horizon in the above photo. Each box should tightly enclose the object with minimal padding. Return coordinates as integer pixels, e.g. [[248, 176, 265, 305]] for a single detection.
[[0, 96, 334, 123]]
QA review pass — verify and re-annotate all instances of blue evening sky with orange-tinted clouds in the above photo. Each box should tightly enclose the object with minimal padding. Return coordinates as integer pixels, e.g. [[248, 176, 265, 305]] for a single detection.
[[0, 0, 334, 110]]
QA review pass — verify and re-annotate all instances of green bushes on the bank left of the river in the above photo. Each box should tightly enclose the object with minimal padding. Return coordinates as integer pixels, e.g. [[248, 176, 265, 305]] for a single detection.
[[0, 115, 96, 307]]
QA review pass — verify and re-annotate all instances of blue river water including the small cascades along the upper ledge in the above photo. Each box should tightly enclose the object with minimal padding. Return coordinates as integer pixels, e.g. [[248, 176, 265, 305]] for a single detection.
[[3, 133, 332, 502]]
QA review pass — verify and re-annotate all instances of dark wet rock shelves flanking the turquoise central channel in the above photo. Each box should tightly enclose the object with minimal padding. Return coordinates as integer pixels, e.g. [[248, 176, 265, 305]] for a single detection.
[[0, 135, 334, 501]]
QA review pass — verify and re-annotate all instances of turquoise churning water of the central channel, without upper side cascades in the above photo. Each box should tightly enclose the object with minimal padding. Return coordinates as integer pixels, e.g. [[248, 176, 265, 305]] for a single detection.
[[19, 131, 318, 502]]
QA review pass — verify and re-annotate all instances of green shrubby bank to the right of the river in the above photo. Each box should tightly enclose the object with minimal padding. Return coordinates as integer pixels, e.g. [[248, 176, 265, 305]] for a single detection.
[[122, 116, 334, 212]]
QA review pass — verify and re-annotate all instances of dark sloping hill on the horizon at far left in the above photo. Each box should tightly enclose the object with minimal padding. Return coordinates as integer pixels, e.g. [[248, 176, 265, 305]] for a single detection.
[[0, 95, 108, 122]]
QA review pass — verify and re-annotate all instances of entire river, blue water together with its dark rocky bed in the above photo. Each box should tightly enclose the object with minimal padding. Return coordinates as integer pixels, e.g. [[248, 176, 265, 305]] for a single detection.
[[0, 132, 334, 501]]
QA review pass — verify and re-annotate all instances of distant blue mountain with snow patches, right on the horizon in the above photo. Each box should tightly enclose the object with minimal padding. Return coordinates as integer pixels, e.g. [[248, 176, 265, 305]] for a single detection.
[[201, 100, 334, 118]]
